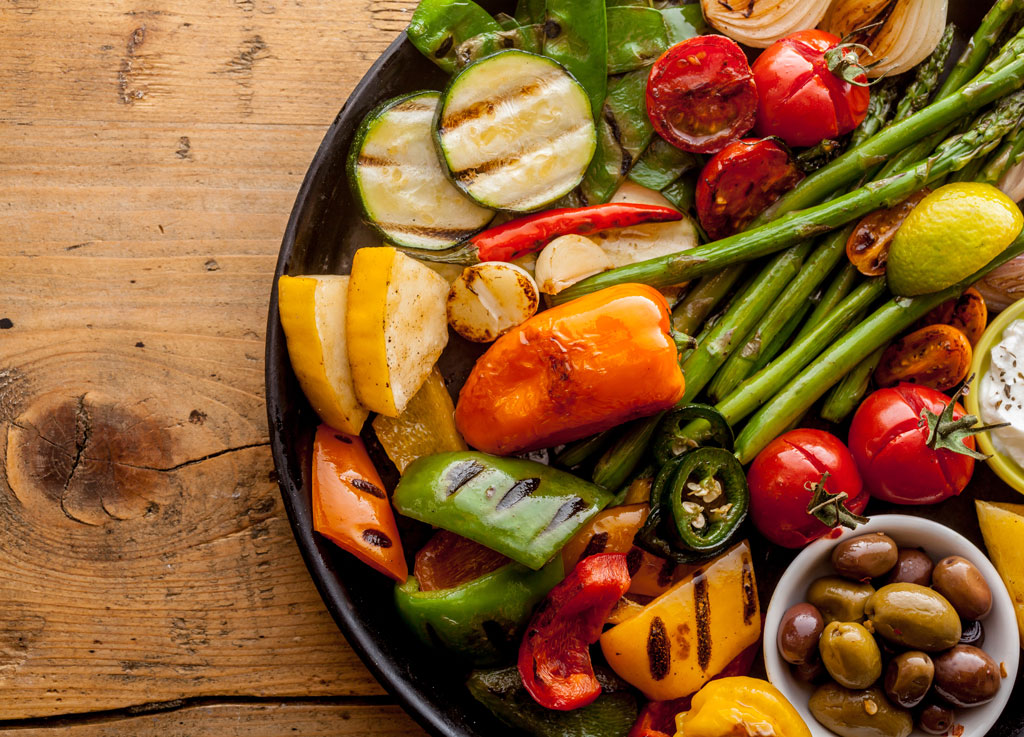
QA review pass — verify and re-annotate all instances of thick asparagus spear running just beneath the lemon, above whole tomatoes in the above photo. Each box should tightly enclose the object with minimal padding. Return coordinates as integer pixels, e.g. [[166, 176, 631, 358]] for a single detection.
[[736, 233, 1024, 464]]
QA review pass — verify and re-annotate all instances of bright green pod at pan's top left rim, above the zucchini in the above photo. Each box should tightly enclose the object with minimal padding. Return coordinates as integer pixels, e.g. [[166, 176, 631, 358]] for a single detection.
[[407, 0, 502, 73]]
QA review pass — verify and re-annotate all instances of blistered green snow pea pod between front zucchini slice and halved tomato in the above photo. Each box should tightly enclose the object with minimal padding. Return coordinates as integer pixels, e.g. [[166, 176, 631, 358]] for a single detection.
[[580, 70, 654, 205]]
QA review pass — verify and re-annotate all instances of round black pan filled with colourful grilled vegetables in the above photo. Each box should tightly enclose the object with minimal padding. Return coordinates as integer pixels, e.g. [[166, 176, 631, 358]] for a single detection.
[[267, 0, 1024, 737]]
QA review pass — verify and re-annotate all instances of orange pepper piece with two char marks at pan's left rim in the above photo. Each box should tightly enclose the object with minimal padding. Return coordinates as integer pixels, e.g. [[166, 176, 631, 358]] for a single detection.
[[312, 425, 409, 581]]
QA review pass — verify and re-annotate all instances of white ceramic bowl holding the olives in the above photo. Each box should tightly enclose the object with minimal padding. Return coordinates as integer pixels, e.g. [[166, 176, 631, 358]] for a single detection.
[[764, 515, 1020, 737]]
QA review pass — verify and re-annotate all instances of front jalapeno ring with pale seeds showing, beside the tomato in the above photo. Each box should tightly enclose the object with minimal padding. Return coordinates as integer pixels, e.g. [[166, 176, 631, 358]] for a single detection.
[[662, 447, 750, 553]]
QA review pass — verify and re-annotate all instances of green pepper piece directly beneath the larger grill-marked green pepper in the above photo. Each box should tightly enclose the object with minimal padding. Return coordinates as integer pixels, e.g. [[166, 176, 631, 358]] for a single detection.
[[394, 556, 563, 664]]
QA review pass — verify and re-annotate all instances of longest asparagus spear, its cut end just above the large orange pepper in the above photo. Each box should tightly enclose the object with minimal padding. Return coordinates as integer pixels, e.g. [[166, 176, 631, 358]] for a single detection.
[[553, 84, 1024, 304]]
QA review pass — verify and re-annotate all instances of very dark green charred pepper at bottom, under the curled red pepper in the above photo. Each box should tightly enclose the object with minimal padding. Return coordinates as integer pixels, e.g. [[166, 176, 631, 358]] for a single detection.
[[466, 666, 637, 737]]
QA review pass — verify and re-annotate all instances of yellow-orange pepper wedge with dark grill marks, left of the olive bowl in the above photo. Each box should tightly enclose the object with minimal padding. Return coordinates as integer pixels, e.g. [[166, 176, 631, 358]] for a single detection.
[[601, 540, 761, 701]]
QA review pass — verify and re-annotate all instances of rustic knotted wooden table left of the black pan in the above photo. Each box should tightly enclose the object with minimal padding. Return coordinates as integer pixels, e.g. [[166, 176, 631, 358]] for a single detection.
[[0, 0, 428, 737]]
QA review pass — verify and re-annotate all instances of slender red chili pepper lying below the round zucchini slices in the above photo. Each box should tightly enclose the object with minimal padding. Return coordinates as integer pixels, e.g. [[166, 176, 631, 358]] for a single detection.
[[469, 203, 683, 261]]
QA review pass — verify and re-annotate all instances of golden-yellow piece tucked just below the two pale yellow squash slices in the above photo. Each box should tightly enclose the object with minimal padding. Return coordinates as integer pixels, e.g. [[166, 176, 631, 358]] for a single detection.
[[374, 366, 468, 473]]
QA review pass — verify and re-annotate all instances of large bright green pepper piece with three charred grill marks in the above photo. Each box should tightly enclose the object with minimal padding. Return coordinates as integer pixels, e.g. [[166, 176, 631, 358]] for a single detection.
[[392, 450, 611, 570]]
